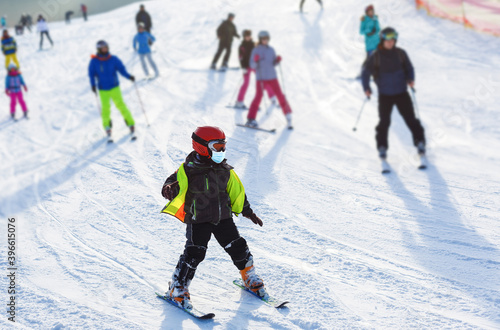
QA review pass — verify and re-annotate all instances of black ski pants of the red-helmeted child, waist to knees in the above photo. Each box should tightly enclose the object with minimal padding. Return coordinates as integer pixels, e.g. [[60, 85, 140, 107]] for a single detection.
[[181, 218, 252, 270]]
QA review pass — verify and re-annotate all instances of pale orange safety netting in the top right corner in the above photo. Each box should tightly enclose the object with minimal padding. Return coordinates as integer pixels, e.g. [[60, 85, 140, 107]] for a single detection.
[[416, 0, 500, 36]]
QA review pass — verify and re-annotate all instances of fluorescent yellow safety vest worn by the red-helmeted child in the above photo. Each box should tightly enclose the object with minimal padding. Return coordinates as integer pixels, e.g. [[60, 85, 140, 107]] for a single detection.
[[161, 163, 245, 222]]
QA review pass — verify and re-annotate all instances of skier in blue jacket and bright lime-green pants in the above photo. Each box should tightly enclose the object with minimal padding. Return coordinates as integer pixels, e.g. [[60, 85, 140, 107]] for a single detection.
[[89, 40, 135, 142]]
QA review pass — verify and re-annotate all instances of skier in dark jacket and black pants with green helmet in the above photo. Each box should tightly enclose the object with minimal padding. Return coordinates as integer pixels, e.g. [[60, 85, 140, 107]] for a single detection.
[[362, 28, 425, 159]]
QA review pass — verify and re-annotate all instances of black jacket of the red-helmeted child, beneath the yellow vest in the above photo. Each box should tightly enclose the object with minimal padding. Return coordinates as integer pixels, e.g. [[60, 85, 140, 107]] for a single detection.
[[163, 151, 253, 225]]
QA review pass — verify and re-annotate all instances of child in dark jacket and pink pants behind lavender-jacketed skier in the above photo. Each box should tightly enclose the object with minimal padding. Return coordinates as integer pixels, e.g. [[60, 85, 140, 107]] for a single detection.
[[234, 30, 277, 109]]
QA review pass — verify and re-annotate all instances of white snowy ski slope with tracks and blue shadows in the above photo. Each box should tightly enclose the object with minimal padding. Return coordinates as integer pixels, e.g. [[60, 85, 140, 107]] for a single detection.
[[0, 0, 500, 329]]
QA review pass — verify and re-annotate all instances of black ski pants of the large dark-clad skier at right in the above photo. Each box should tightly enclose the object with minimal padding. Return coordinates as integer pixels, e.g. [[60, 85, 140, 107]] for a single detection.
[[375, 92, 425, 149]]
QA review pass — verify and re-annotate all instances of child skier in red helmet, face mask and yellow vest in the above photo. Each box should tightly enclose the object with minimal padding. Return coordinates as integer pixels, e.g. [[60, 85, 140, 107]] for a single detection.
[[162, 126, 267, 309]]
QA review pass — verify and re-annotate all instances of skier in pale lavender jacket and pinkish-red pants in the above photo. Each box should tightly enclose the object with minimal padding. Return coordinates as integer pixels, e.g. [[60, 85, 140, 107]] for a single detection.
[[245, 31, 292, 129]]
